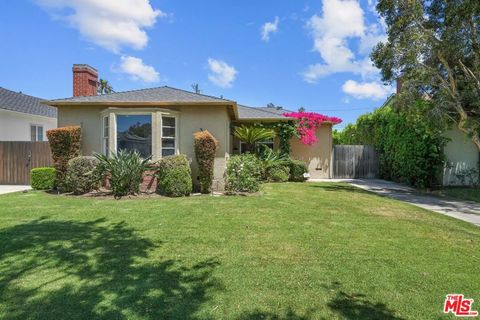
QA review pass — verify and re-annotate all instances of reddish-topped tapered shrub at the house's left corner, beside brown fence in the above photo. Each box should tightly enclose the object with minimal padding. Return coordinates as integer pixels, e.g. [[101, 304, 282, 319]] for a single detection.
[[47, 126, 82, 191]]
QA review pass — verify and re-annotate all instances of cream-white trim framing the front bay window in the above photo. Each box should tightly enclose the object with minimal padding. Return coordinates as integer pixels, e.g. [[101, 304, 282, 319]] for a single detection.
[[100, 107, 180, 161]]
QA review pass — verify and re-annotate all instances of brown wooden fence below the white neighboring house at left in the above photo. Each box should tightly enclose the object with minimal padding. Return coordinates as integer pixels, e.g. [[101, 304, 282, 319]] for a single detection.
[[0, 141, 52, 184]]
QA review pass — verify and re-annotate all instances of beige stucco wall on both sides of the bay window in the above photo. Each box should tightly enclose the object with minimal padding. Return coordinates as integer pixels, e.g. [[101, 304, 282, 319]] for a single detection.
[[58, 106, 230, 190]]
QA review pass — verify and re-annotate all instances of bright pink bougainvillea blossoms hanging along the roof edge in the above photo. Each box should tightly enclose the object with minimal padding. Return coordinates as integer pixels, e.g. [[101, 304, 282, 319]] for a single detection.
[[283, 112, 342, 146]]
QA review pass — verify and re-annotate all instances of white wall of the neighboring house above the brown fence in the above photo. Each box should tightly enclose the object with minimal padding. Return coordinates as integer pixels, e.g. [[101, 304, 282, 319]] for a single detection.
[[0, 109, 57, 141]]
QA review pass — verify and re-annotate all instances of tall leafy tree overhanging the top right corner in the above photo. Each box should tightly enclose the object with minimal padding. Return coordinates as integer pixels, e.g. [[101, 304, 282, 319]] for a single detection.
[[371, 0, 480, 150]]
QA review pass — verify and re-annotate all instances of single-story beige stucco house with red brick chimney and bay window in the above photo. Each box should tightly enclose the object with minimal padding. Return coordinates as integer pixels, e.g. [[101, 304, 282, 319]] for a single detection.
[[44, 64, 338, 190]]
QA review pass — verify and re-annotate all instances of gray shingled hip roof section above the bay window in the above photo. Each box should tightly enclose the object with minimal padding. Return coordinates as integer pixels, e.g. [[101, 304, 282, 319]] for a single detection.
[[51, 86, 233, 103]]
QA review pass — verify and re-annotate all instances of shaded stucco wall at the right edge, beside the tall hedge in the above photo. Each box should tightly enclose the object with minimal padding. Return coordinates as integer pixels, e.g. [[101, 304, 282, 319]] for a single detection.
[[443, 129, 479, 186]]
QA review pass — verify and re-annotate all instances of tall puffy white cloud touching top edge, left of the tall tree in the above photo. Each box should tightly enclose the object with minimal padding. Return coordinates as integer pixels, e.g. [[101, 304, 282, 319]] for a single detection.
[[303, 0, 385, 83]]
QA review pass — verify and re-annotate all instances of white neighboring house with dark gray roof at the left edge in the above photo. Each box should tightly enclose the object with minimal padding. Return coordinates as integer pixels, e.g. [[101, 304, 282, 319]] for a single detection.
[[0, 87, 57, 141]]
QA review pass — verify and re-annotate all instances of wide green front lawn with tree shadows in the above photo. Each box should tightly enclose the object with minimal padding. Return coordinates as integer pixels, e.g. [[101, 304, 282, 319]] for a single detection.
[[0, 183, 480, 320]]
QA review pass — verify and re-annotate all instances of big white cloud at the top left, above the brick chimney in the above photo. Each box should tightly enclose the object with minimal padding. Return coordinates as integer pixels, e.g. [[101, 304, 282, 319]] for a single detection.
[[36, 0, 166, 52]]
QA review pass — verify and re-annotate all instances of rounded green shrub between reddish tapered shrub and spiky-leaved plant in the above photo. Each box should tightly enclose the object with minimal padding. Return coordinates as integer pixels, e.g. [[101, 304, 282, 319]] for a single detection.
[[65, 156, 101, 194]]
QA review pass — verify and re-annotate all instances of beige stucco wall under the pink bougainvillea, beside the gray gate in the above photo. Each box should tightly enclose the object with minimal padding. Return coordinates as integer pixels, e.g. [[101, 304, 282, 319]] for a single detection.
[[290, 125, 332, 179]]
